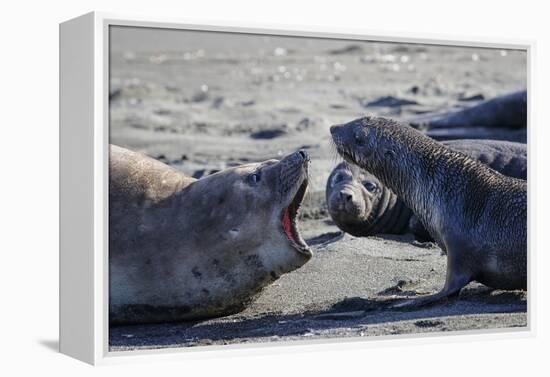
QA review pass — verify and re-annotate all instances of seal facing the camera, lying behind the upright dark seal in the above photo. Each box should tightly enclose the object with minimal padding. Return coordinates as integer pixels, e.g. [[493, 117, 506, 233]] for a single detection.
[[326, 140, 527, 241]]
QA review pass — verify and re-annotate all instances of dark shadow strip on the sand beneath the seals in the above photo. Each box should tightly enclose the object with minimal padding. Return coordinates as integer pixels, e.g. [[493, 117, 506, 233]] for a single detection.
[[109, 287, 527, 349]]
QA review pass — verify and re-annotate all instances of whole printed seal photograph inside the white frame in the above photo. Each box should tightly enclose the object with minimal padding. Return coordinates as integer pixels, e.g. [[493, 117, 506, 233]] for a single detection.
[[108, 26, 528, 351]]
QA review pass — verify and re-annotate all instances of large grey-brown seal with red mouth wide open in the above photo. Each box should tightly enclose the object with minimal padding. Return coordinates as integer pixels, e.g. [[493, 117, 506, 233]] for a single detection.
[[109, 145, 312, 325]]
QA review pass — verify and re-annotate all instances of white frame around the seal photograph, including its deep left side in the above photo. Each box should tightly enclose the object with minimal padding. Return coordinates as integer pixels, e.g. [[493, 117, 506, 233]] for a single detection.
[[59, 12, 536, 364]]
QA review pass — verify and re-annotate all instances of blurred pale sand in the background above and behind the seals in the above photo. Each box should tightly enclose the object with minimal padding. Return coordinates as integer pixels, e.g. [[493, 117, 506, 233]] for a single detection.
[[110, 27, 527, 195]]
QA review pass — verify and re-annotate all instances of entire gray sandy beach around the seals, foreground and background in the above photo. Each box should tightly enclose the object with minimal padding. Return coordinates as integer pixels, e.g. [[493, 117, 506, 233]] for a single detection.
[[110, 28, 527, 350]]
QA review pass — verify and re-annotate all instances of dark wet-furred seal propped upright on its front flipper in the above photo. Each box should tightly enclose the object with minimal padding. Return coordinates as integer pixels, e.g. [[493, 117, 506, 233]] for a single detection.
[[330, 117, 527, 307]]
